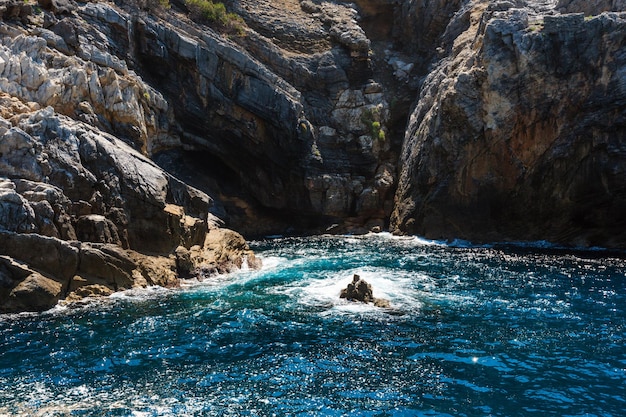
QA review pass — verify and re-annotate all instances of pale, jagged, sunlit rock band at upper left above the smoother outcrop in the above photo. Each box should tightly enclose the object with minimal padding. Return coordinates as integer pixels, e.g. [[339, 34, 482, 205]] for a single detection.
[[0, 17, 175, 152]]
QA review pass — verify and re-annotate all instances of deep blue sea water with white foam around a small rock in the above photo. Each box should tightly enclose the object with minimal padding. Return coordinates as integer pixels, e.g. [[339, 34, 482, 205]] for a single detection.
[[0, 234, 626, 417]]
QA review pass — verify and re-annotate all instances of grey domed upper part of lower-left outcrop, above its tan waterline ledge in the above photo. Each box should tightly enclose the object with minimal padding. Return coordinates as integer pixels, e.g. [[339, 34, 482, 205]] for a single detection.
[[0, 107, 211, 253]]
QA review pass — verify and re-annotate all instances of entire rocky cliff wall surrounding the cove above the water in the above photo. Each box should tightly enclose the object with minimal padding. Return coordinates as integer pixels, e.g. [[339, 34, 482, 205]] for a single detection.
[[0, 0, 626, 312]]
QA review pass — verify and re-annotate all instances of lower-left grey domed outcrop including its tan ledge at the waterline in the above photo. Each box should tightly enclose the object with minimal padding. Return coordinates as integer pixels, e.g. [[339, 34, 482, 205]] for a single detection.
[[0, 106, 258, 312]]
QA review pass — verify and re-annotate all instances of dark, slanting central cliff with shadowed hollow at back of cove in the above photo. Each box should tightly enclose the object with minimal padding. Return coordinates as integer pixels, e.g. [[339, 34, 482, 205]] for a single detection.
[[136, 0, 395, 231]]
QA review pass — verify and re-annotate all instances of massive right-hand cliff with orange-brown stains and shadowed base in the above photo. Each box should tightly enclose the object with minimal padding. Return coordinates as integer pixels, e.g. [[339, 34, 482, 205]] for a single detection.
[[391, 1, 626, 247]]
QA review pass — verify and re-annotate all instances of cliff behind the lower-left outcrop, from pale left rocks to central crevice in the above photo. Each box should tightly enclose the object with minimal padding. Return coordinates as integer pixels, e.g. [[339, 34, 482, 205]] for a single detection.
[[0, 0, 400, 234]]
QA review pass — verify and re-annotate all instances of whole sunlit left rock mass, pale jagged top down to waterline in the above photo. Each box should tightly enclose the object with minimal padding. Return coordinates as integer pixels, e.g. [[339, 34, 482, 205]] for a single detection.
[[0, 2, 258, 312]]
